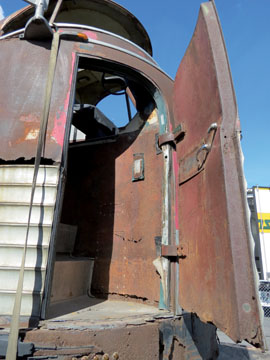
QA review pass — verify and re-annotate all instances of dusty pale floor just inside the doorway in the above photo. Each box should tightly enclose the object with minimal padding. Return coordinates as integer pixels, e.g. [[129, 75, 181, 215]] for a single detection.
[[43, 296, 173, 329]]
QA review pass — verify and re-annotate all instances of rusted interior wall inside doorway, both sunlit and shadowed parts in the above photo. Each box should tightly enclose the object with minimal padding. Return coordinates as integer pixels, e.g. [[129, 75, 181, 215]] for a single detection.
[[61, 115, 163, 304]]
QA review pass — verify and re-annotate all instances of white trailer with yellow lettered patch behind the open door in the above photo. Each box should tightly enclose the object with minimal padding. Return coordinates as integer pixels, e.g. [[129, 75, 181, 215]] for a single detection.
[[248, 186, 270, 316]]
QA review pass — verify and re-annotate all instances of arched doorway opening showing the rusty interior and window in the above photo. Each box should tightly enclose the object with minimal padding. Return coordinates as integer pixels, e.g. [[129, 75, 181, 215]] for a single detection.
[[48, 57, 168, 319]]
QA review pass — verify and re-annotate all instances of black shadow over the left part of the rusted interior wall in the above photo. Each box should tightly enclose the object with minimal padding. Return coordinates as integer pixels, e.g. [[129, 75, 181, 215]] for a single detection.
[[49, 130, 140, 314]]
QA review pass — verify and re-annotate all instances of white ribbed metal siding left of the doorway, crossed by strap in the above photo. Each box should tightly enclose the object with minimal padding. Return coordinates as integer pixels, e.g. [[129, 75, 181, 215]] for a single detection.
[[0, 165, 59, 325]]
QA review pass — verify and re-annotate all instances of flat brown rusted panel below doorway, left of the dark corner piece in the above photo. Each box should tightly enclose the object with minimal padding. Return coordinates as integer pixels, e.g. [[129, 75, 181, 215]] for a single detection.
[[25, 321, 160, 360]]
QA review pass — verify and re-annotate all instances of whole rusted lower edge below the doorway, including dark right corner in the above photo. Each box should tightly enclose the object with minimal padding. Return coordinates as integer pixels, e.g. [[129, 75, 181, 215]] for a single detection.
[[24, 314, 219, 360]]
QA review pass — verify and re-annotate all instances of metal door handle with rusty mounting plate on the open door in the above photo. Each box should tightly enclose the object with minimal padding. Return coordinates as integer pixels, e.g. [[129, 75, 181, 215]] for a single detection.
[[179, 123, 218, 185]]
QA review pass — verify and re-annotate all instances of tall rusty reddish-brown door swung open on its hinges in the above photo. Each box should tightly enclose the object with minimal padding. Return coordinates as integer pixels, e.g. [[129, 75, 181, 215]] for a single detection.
[[174, 2, 263, 347]]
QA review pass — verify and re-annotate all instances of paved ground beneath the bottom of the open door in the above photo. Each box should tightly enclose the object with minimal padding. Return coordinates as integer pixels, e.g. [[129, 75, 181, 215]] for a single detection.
[[218, 317, 270, 360]]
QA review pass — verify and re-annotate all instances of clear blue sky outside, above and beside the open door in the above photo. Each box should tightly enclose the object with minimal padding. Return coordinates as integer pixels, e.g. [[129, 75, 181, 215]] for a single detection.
[[0, 0, 270, 187]]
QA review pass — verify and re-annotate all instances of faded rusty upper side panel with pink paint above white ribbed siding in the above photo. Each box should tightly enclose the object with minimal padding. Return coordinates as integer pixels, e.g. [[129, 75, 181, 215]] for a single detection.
[[0, 39, 75, 162]]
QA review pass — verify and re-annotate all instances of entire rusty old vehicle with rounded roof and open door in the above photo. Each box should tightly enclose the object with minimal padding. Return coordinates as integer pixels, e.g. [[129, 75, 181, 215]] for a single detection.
[[0, 0, 264, 359]]
